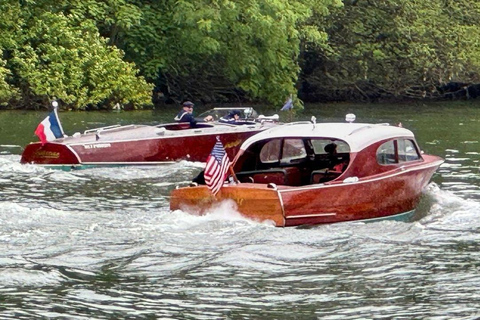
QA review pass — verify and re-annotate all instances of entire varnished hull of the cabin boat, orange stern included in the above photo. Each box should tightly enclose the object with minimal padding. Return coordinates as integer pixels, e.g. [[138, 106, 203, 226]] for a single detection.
[[170, 156, 443, 227]]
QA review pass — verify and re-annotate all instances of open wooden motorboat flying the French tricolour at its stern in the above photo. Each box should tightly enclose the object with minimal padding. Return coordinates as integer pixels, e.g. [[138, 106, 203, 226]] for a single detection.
[[20, 108, 278, 170]]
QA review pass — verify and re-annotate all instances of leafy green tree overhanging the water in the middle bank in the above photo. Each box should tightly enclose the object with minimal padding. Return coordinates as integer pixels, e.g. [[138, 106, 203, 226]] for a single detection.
[[122, 0, 341, 104]]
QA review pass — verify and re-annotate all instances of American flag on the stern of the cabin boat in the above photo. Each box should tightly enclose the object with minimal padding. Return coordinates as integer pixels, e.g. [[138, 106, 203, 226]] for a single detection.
[[204, 138, 230, 195]]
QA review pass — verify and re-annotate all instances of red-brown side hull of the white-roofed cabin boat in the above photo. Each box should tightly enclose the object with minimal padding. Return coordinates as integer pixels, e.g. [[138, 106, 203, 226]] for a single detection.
[[279, 161, 441, 226]]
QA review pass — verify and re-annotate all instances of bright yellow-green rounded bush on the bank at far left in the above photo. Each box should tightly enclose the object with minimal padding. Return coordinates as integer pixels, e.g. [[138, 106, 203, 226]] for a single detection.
[[2, 1, 152, 109]]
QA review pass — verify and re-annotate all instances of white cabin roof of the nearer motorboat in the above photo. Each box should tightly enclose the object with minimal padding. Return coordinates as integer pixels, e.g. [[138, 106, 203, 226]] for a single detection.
[[241, 122, 414, 152]]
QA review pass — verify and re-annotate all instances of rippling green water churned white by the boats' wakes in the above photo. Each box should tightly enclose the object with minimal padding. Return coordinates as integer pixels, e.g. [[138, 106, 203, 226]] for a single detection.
[[0, 102, 480, 319]]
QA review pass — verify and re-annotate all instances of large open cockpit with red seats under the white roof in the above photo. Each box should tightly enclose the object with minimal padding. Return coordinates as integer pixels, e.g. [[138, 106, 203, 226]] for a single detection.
[[235, 138, 350, 186]]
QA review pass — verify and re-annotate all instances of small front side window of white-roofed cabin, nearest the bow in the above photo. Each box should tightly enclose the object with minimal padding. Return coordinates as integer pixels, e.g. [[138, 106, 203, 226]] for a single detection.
[[377, 139, 421, 164]]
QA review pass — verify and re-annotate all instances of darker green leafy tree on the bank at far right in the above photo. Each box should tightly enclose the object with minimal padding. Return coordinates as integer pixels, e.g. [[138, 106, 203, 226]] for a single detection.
[[305, 0, 480, 98]]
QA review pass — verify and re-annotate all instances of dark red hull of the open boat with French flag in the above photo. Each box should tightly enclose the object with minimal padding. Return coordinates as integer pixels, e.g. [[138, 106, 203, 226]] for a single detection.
[[20, 125, 260, 166]]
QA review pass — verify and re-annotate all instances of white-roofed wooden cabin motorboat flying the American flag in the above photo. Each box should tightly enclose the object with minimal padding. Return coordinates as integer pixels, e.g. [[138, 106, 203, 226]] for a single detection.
[[170, 116, 443, 227]]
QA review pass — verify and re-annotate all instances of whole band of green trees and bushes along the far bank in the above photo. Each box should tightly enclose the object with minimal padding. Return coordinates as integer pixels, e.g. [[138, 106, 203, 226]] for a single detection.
[[0, 0, 480, 110]]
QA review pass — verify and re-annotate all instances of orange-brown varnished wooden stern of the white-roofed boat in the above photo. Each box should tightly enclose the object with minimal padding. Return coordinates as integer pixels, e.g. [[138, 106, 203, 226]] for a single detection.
[[170, 183, 285, 227]]
